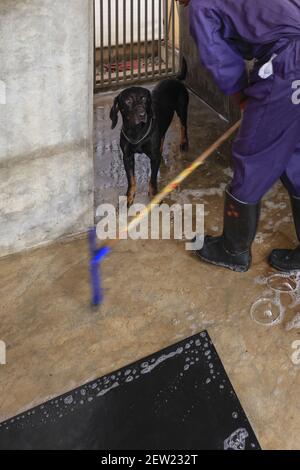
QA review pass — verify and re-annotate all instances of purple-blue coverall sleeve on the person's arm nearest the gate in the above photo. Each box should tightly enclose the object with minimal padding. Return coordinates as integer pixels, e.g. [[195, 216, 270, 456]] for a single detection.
[[190, 2, 248, 95]]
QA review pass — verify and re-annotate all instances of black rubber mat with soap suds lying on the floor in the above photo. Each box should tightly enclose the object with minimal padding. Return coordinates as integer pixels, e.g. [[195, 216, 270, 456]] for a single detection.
[[0, 332, 260, 450]]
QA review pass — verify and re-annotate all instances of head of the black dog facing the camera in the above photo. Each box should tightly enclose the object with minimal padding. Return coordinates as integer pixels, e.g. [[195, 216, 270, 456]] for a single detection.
[[110, 87, 153, 129]]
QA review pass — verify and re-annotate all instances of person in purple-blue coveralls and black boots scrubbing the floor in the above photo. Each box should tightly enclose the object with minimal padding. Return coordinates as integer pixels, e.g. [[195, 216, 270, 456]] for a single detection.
[[179, 0, 300, 271]]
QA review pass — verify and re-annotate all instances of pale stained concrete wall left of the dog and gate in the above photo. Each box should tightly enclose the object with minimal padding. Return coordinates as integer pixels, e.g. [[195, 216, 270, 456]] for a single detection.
[[0, 0, 93, 256]]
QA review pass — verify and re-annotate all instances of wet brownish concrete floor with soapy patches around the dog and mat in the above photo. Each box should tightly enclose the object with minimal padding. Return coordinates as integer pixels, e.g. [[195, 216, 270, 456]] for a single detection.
[[0, 84, 300, 449]]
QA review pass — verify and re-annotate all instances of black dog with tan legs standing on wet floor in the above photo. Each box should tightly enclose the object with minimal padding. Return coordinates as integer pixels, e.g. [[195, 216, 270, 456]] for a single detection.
[[110, 79, 189, 206]]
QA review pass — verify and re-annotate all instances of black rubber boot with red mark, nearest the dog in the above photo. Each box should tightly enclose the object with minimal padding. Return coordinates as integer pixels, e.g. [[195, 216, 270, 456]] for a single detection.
[[196, 190, 260, 272]]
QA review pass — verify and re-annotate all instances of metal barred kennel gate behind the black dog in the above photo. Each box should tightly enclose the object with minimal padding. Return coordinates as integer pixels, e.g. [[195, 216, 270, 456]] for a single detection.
[[94, 0, 179, 90]]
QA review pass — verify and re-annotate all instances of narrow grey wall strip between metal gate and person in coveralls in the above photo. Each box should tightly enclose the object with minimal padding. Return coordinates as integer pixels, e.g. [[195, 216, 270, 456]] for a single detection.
[[180, 8, 240, 121]]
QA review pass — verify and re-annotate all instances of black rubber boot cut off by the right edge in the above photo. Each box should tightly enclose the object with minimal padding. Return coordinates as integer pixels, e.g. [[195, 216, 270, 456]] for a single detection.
[[269, 196, 300, 272]]
